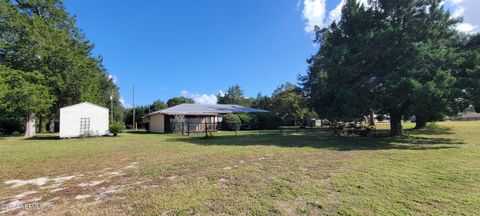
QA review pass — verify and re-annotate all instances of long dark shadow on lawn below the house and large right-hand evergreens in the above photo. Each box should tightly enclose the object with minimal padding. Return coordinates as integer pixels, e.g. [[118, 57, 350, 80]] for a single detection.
[[171, 131, 463, 151]]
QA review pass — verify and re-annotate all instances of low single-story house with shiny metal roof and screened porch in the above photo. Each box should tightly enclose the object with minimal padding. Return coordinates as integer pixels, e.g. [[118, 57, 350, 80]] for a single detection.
[[144, 104, 269, 133]]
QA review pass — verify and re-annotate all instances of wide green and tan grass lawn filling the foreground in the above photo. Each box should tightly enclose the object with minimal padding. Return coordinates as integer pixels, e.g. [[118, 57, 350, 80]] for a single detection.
[[0, 122, 480, 215]]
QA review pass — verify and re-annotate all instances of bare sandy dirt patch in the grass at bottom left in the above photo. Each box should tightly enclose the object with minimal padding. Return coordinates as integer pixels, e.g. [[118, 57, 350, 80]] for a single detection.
[[0, 162, 142, 214]]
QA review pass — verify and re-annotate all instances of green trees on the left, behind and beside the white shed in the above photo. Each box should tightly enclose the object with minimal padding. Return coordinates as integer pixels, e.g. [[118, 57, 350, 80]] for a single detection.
[[0, 0, 123, 137]]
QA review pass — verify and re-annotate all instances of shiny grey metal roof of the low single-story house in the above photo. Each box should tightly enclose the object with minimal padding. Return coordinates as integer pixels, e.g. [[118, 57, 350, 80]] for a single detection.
[[148, 104, 270, 116]]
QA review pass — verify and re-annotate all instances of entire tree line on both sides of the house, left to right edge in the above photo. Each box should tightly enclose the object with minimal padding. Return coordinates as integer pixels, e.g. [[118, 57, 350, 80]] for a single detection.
[[0, 0, 480, 136]]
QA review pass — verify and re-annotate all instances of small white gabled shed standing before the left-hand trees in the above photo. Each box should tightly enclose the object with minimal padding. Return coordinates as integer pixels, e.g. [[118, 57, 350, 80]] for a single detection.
[[60, 102, 109, 138]]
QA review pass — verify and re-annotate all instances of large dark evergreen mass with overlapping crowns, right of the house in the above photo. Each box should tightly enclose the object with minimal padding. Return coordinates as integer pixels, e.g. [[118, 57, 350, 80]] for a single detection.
[[301, 0, 459, 136]]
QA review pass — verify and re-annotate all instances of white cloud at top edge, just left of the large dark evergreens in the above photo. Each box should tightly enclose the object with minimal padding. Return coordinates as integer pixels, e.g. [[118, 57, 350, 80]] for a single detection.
[[302, 0, 326, 33]]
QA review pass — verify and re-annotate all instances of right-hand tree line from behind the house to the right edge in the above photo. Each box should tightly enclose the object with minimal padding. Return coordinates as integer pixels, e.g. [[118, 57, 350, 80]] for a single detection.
[[218, 0, 480, 136]]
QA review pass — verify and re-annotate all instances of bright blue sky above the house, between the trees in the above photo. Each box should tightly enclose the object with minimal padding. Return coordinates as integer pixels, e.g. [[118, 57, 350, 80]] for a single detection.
[[65, 0, 479, 106]]
